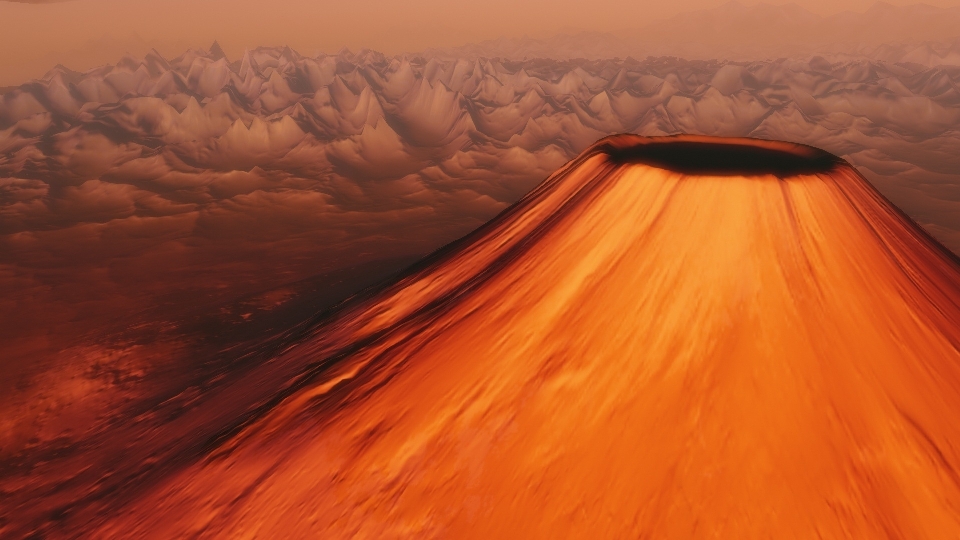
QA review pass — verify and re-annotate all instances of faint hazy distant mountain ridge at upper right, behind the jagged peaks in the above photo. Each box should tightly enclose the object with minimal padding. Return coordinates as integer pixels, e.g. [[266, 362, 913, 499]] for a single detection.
[[434, 3, 960, 62]]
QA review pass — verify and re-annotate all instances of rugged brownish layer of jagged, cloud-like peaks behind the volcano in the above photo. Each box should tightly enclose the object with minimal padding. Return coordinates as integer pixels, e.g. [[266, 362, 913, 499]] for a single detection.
[[0, 48, 960, 286]]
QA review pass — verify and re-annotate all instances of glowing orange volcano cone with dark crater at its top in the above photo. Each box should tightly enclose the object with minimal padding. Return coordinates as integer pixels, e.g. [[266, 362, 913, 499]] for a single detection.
[[16, 135, 960, 539]]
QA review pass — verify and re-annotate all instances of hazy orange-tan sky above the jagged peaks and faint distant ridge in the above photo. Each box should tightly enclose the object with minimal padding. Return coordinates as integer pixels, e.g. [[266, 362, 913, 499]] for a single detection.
[[0, 0, 960, 85]]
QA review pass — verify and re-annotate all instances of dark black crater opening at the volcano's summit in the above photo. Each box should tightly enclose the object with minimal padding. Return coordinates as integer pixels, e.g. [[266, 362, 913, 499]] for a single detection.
[[603, 141, 839, 178]]
